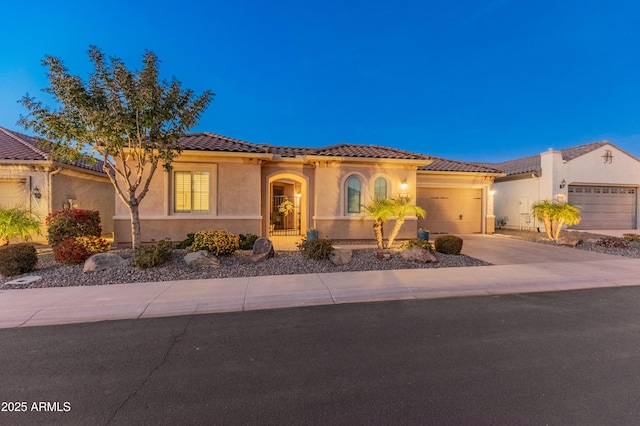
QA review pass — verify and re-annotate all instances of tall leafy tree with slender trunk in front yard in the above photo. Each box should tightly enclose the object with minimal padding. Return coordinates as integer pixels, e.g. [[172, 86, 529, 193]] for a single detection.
[[20, 46, 214, 248]]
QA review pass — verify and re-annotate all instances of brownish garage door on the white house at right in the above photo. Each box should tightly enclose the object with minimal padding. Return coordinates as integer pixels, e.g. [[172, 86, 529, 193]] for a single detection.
[[569, 185, 638, 229]]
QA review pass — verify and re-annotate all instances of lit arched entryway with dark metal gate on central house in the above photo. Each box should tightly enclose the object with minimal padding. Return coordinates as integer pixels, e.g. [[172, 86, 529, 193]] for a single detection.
[[265, 172, 307, 237]]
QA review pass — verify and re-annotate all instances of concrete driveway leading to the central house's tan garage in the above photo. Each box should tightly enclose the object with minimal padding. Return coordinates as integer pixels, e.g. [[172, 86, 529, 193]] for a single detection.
[[461, 234, 620, 265]]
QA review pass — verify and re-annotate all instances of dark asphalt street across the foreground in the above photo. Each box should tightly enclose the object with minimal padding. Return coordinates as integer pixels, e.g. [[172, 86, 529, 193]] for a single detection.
[[0, 287, 640, 425]]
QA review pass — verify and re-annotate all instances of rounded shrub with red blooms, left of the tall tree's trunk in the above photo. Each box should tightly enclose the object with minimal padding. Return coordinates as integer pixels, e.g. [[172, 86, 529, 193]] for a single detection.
[[45, 209, 102, 246]]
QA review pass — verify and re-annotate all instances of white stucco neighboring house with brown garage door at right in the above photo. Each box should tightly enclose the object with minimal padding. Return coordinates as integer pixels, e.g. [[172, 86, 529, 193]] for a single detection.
[[484, 141, 640, 229]]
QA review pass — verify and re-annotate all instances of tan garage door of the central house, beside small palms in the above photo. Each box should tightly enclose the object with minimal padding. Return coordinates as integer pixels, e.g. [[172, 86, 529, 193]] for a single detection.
[[416, 188, 482, 234]]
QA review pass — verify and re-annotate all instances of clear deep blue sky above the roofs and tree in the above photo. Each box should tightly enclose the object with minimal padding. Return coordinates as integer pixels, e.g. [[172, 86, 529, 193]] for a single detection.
[[0, 0, 640, 161]]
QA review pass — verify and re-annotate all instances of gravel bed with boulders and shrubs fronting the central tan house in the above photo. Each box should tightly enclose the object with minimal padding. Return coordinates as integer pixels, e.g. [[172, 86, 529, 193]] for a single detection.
[[0, 249, 489, 289]]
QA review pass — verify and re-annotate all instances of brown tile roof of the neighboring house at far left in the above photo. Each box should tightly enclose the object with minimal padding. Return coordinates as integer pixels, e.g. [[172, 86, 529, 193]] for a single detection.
[[0, 127, 104, 173]]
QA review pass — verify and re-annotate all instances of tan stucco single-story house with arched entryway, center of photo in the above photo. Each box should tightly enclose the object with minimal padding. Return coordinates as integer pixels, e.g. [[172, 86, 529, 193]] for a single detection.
[[114, 133, 504, 245]]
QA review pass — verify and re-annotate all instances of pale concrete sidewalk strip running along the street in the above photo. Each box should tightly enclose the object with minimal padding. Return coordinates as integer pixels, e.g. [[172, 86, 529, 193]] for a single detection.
[[0, 250, 640, 328]]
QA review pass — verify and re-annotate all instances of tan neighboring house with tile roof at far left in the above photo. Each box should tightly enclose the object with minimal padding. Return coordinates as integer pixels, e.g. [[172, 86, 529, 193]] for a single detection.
[[0, 127, 115, 242]]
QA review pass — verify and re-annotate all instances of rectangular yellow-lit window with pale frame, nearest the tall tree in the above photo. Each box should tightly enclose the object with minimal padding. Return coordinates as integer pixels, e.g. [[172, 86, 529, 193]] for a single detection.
[[173, 172, 209, 213]]
